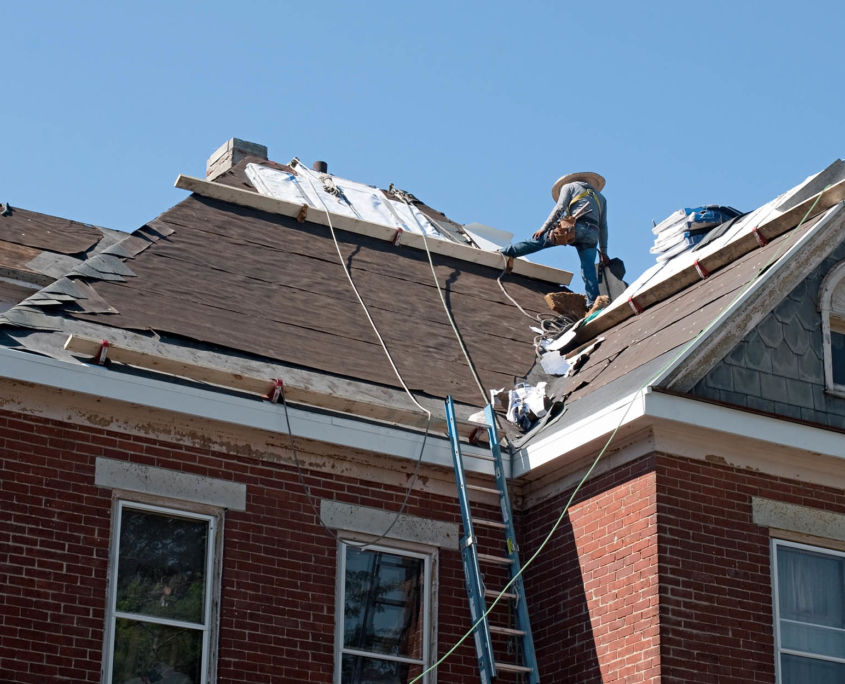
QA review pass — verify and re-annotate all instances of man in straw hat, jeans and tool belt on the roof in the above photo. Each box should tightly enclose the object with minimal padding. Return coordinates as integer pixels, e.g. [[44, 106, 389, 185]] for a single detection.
[[501, 172, 610, 308]]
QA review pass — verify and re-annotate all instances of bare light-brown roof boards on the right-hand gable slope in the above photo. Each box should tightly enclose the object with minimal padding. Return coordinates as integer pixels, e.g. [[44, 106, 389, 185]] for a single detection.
[[551, 217, 820, 402]]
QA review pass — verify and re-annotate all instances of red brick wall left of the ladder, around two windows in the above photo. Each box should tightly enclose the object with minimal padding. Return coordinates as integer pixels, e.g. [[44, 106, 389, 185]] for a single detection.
[[0, 412, 478, 684]]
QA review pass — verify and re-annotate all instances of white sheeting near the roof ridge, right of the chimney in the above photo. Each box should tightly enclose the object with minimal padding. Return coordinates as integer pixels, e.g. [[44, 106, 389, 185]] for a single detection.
[[246, 164, 440, 238]]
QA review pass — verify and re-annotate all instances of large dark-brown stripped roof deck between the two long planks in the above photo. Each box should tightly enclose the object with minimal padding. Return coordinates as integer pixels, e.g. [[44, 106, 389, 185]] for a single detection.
[[72, 196, 549, 404]]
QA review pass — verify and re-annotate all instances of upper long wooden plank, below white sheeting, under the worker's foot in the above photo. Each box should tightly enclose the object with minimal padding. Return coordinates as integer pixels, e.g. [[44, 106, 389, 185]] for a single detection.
[[175, 174, 572, 285]]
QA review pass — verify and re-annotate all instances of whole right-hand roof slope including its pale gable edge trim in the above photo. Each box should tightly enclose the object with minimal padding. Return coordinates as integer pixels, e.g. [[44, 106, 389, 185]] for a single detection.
[[524, 162, 845, 443]]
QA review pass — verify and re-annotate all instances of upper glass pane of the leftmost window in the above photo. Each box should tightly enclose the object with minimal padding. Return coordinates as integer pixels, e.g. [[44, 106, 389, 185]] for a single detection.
[[116, 508, 208, 623]]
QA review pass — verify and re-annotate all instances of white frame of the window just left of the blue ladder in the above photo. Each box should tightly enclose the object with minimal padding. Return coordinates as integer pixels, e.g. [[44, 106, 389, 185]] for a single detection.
[[334, 535, 437, 684]]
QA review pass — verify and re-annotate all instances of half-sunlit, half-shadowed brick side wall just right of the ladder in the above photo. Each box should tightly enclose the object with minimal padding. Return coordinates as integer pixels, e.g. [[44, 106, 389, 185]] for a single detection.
[[522, 458, 660, 684]]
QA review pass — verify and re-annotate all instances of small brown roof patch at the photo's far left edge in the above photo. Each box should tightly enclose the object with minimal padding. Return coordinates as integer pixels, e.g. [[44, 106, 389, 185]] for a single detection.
[[0, 207, 103, 255]]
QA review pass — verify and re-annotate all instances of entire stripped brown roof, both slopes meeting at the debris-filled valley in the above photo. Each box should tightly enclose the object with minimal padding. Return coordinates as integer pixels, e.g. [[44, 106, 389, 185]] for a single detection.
[[0, 152, 842, 470]]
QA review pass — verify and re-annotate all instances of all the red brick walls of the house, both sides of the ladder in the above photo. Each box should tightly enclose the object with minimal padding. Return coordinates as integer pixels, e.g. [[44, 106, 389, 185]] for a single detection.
[[6, 398, 845, 684]]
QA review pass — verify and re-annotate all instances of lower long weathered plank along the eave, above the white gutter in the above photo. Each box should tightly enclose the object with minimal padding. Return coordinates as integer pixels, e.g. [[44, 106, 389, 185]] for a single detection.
[[64, 335, 504, 439]]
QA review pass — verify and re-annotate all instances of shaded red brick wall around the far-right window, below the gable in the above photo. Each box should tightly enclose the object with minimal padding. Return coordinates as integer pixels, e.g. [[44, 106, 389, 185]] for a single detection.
[[657, 456, 845, 684]]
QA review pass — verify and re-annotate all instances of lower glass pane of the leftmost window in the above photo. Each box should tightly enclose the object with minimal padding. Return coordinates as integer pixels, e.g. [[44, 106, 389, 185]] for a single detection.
[[112, 619, 202, 684]]
